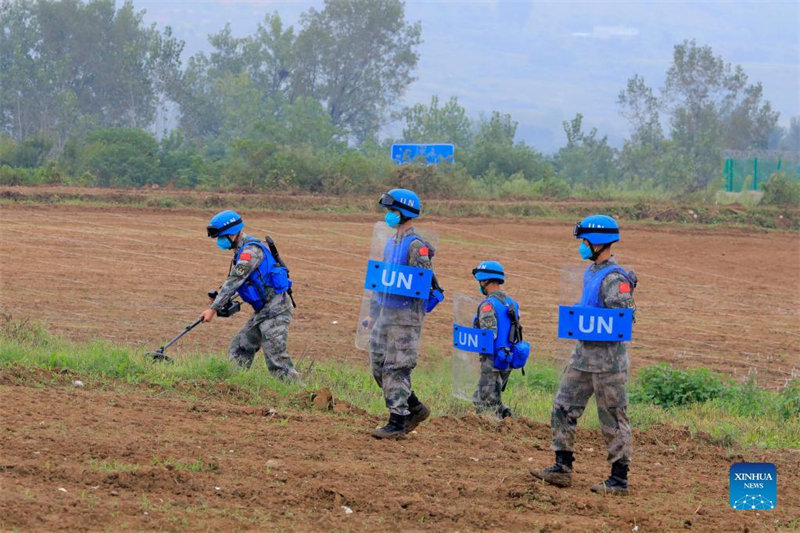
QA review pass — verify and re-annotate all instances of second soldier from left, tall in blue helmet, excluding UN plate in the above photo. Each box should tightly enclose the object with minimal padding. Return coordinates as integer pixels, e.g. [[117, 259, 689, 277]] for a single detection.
[[367, 189, 434, 439]]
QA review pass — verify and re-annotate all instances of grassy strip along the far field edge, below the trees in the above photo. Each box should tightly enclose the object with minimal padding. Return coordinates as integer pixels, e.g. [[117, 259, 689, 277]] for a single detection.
[[0, 187, 800, 231]]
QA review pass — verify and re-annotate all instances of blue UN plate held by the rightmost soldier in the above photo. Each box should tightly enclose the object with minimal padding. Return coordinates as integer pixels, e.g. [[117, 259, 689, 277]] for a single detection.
[[558, 305, 633, 342]]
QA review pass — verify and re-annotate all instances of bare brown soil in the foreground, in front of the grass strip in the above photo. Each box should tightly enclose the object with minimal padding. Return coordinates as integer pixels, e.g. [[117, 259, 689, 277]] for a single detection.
[[0, 369, 800, 531]]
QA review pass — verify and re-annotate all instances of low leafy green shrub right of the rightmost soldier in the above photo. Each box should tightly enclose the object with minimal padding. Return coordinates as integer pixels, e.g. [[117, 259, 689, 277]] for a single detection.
[[631, 363, 724, 407]]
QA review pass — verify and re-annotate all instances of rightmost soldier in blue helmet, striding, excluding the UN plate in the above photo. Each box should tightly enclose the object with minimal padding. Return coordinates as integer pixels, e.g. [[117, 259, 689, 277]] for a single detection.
[[531, 215, 636, 494]]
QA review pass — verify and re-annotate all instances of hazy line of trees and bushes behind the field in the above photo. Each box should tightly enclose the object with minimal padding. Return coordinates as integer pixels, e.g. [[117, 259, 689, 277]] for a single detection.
[[0, 0, 800, 202]]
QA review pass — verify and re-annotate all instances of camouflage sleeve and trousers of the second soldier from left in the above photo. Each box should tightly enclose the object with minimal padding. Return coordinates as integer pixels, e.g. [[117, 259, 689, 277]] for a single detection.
[[369, 227, 433, 416]]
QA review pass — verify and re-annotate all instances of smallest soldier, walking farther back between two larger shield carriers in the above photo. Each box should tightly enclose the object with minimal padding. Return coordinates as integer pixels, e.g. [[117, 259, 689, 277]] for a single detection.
[[472, 261, 519, 418]]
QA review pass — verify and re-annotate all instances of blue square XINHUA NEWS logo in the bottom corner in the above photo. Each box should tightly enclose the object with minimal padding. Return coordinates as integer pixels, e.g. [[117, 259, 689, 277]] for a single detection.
[[730, 463, 778, 511]]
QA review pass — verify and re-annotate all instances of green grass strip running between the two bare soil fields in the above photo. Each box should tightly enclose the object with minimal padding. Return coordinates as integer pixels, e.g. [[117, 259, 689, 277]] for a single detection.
[[0, 320, 800, 448]]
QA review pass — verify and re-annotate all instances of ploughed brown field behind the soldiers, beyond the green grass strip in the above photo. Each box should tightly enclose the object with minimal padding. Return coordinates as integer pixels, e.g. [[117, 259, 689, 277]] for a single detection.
[[0, 200, 800, 386]]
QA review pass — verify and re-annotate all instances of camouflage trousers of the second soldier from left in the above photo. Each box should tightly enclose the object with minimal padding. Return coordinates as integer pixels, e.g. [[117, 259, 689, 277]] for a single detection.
[[369, 323, 422, 416]]
